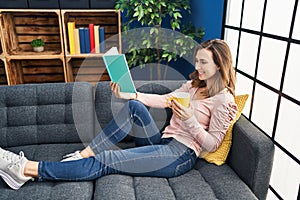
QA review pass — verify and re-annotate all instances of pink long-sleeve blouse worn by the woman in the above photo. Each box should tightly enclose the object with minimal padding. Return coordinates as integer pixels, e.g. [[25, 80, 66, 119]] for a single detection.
[[137, 81, 237, 156]]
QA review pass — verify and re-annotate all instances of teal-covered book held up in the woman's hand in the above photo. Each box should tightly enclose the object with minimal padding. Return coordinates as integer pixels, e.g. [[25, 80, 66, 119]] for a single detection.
[[103, 47, 136, 93]]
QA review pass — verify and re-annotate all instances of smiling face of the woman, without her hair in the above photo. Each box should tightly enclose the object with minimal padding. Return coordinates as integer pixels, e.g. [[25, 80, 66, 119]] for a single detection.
[[195, 49, 219, 80]]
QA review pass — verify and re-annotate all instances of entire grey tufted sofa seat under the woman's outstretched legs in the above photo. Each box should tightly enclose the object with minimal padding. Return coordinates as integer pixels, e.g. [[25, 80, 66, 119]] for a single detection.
[[0, 143, 257, 200]]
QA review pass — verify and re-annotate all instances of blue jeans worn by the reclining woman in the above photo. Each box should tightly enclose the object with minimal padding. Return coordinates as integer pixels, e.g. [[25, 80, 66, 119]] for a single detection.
[[38, 100, 197, 181]]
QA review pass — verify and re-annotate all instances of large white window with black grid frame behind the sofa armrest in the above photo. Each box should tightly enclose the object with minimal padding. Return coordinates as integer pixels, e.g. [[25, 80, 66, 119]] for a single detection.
[[223, 0, 300, 200]]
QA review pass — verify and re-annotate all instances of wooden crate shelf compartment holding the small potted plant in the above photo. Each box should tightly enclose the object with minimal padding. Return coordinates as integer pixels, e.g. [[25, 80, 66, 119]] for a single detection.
[[1, 10, 64, 56]]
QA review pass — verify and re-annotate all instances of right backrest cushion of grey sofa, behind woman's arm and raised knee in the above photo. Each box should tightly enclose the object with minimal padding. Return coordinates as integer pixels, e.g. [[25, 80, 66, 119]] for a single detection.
[[95, 80, 186, 134]]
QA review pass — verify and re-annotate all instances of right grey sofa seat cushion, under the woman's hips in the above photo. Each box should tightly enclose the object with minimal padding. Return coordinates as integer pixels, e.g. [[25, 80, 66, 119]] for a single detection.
[[94, 159, 257, 200]]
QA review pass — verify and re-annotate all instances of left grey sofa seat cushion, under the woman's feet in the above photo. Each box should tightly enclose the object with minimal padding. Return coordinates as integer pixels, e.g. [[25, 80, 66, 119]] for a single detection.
[[0, 143, 94, 200]]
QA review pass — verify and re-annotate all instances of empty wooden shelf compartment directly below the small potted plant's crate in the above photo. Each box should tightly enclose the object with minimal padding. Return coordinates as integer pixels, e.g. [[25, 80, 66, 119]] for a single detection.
[[8, 59, 65, 85]]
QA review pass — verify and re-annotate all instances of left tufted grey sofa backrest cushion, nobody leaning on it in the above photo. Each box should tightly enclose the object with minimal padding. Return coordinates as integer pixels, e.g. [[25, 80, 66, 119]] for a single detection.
[[0, 83, 94, 147]]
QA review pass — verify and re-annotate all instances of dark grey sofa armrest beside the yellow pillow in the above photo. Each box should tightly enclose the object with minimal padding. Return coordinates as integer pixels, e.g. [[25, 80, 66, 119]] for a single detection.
[[227, 115, 274, 199]]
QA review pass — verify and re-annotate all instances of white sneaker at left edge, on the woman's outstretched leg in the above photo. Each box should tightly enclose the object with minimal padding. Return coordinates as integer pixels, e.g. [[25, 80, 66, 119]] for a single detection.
[[0, 148, 32, 190]]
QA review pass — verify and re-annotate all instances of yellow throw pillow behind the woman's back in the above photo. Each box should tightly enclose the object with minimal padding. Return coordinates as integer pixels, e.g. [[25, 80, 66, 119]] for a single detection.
[[204, 94, 249, 166]]
